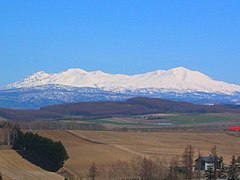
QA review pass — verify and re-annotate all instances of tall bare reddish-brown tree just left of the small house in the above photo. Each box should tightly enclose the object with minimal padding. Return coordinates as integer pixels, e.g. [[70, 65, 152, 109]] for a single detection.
[[182, 145, 194, 180]]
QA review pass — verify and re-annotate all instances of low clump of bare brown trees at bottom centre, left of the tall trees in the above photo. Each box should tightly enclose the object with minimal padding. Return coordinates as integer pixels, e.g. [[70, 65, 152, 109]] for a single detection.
[[87, 156, 168, 180]]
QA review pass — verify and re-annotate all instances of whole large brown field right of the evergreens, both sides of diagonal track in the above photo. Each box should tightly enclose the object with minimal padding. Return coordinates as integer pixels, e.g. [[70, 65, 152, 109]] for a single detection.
[[32, 131, 240, 176]]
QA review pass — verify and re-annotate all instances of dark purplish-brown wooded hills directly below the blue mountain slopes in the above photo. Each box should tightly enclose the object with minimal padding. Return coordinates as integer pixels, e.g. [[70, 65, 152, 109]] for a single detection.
[[0, 97, 240, 121]]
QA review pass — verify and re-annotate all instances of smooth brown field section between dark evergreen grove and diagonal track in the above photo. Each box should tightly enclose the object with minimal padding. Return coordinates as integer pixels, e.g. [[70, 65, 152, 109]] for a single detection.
[[31, 130, 132, 177]]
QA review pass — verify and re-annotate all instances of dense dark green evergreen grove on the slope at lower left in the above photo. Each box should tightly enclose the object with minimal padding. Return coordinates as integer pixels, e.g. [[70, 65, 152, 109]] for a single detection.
[[13, 130, 68, 171]]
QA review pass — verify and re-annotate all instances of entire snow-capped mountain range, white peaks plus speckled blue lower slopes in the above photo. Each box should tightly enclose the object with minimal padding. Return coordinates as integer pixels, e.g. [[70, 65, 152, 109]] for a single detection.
[[0, 67, 240, 108]]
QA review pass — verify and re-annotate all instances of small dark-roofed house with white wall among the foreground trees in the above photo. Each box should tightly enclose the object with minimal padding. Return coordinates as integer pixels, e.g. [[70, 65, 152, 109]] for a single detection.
[[195, 156, 222, 171]]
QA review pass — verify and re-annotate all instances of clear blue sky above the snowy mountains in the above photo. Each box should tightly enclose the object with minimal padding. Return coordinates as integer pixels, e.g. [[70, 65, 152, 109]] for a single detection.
[[0, 0, 240, 86]]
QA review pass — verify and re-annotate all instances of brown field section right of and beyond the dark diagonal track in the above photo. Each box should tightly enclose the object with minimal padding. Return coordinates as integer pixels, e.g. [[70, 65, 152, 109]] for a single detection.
[[72, 131, 240, 163]]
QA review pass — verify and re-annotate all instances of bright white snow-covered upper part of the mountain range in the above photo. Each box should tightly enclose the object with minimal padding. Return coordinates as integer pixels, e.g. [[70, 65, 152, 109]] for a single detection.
[[4, 67, 240, 94]]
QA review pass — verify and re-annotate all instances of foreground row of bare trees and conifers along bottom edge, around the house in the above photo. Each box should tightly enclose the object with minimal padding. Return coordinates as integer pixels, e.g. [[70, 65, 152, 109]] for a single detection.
[[87, 145, 240, 180]]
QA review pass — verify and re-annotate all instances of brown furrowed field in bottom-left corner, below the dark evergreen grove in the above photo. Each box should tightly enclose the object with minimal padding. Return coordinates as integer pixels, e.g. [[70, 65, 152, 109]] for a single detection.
[[0, 148, 64, 180]]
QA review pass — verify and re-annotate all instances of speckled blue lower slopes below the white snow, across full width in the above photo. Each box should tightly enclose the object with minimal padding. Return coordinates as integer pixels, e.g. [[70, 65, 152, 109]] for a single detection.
[[0, 84, 240, 109]]
